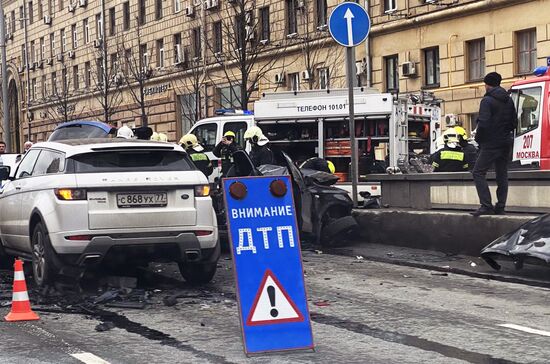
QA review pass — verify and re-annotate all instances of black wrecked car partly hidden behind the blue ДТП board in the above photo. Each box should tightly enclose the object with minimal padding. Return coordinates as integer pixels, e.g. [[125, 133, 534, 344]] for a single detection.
[[212, 151, 358, 246]]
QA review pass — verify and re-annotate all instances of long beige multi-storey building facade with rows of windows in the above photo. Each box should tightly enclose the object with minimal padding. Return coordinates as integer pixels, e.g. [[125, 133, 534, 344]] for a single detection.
[[3, 0, 550, 151]]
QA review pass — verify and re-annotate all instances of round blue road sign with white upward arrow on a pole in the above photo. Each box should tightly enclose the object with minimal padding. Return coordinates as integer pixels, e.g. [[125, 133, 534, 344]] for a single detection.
[[328, 2, 370, 47]]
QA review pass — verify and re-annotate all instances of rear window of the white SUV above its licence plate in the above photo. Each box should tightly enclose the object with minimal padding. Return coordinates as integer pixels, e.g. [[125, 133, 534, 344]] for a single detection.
[[70, 150, 196, 173]]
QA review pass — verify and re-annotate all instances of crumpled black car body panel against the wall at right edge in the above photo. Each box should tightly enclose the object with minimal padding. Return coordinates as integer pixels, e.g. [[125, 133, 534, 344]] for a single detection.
[[481, 214, 550, 270]]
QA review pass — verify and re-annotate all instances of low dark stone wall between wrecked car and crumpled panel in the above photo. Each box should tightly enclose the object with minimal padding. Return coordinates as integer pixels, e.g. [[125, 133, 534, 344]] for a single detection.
[[353, 209, 536, 256]]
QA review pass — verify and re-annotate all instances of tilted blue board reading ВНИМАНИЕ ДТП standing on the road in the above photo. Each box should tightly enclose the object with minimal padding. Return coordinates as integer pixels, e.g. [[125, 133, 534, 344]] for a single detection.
[[223, 176, 313, 353]]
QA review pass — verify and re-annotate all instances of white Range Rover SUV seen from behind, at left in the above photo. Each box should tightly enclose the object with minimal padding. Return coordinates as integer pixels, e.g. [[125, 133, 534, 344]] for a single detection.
[[0, 139, 220, 286]]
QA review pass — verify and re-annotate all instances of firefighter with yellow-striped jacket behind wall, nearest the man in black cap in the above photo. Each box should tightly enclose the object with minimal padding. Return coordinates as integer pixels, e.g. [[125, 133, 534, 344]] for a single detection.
[[431, 128, 468, 172]]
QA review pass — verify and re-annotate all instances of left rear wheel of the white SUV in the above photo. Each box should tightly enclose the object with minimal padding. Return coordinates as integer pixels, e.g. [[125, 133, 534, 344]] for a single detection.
[[31, 223, 53, 287]]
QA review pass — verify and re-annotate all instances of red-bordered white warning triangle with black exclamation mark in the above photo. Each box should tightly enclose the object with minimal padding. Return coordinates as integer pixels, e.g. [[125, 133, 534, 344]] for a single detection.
[[246, 269, 304, 326]]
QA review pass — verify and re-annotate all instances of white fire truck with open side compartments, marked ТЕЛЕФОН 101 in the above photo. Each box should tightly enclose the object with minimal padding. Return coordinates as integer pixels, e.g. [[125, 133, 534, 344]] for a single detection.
[[190, 87, 441, 196]]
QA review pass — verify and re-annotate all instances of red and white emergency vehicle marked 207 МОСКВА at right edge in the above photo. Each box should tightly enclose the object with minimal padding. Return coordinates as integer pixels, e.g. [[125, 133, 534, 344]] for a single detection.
[[510, 66, 550, 170]]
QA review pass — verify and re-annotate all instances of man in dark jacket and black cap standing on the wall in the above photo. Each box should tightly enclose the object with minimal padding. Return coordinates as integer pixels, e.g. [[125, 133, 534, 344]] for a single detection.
[[471, 72, 517, 216]]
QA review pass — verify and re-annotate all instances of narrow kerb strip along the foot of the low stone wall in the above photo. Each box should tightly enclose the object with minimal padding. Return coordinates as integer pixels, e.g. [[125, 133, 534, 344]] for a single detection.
[[323, 241, 550, 288]]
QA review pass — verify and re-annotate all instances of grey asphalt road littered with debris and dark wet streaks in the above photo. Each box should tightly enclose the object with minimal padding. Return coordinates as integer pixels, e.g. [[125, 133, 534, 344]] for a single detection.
[[0, 252, 550, 364]]
